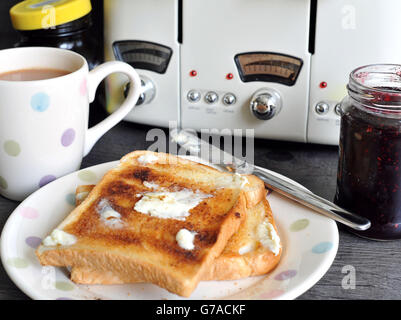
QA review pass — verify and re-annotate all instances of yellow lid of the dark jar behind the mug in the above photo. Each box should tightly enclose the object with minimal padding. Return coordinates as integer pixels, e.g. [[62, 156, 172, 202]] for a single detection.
[[10, 0, 92, 31]]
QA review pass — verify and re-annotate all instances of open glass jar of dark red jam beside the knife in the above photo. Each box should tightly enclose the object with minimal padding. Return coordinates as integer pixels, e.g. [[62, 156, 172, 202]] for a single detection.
[[335, 65, 401, 240]]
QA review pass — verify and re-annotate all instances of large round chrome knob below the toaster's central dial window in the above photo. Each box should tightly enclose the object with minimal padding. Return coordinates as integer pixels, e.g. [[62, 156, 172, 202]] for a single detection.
[[250, 89, 281, 120]]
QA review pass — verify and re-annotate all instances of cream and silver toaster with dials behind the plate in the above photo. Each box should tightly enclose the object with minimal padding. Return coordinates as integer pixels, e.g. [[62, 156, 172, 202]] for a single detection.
[[105, 0, 401, 145]]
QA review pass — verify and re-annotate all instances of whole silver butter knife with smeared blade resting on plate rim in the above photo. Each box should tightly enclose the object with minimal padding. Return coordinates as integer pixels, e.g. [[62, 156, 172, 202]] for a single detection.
[[170, 129, 370, 230]]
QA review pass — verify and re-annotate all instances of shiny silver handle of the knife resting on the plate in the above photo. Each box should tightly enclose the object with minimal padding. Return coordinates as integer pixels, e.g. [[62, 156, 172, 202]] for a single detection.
[[253, 166, 370, 230]]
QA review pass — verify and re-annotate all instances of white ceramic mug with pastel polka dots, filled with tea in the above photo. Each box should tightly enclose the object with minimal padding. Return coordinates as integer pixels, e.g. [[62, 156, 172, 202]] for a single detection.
[[0, 47, 141, 200]]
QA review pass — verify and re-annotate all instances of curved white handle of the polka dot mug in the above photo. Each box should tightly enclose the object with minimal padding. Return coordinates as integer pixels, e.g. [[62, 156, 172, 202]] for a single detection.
[[84, 61, 142, 156]]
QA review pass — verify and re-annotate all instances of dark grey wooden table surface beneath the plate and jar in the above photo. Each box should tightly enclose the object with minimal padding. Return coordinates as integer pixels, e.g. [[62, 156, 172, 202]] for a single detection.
[[0, 122, 401, 299]]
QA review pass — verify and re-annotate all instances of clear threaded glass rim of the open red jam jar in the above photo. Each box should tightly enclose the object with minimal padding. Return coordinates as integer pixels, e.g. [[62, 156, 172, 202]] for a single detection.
[[347, 64, 401, 116]]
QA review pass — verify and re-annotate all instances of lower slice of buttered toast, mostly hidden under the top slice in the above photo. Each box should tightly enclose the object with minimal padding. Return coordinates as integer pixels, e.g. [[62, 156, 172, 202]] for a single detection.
[[71, 194, 282, 284]]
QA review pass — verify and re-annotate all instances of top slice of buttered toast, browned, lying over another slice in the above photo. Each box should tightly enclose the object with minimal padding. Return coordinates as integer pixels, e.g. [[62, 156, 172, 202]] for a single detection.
[[36, 151, 247, 296]]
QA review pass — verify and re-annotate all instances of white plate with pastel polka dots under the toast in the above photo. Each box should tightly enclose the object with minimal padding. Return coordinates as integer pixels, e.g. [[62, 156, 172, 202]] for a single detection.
[[1, 161, 338, 300]]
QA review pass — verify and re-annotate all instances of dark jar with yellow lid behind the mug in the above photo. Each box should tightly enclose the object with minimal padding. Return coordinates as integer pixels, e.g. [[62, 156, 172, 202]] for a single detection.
[[10, 0, 103, 69]]
